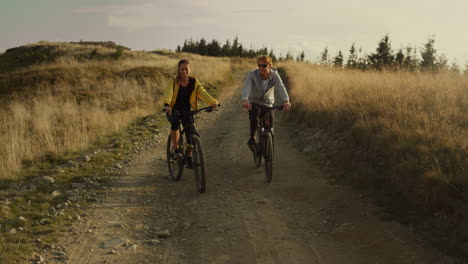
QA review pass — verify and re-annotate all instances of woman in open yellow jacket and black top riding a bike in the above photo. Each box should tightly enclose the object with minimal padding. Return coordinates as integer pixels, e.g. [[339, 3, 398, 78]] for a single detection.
[[164, 60, 218, 168]]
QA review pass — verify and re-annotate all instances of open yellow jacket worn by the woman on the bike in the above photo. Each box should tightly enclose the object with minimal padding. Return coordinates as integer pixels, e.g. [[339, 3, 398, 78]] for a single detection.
[[164, 76, 218, 110]]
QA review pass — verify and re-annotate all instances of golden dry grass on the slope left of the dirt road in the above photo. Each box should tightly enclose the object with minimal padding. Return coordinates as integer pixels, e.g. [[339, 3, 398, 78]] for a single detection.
[[0, 43, 231, 179]]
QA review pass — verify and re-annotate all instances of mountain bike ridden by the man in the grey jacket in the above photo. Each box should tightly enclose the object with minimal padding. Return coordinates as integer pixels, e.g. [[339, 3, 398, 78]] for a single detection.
[[251, 103, 283, 182]]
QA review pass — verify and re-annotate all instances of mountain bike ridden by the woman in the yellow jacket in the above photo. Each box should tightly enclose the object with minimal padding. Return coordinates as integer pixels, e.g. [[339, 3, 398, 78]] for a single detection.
[[166, 106, 218, 193]]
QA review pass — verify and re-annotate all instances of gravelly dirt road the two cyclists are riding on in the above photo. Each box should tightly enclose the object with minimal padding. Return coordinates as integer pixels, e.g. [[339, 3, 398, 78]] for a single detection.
[[46, 81, 452, 264]]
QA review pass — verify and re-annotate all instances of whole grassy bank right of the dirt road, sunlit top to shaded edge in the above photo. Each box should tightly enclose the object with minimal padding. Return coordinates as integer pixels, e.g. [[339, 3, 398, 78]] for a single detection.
[[281, 62, 468, 257]]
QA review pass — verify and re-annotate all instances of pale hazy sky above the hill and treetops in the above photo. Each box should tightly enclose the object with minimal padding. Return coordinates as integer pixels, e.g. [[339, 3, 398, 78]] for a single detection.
[[0, 0, 468, 67]]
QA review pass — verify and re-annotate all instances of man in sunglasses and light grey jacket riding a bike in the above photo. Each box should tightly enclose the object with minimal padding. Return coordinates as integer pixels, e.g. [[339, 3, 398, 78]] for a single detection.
[[242, 55, 291, 148]]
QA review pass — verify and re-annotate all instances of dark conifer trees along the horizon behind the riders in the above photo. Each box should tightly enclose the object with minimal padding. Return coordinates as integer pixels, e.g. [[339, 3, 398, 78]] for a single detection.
[[176, 34, 468, 73]]
